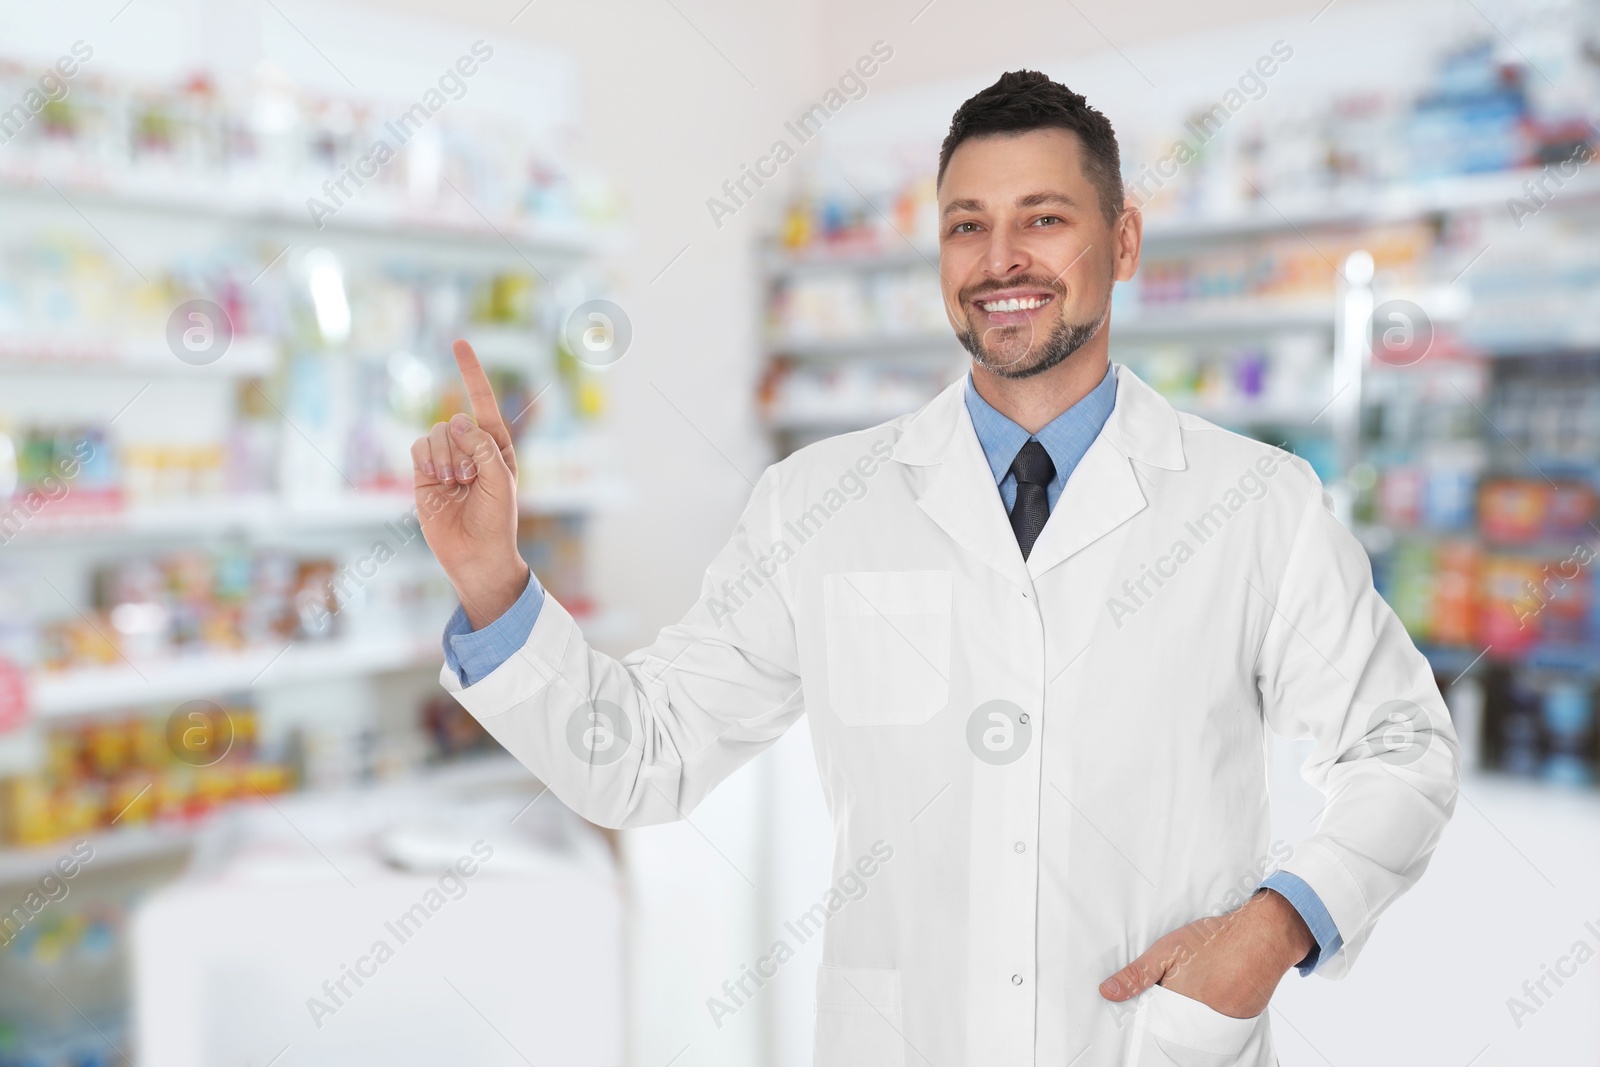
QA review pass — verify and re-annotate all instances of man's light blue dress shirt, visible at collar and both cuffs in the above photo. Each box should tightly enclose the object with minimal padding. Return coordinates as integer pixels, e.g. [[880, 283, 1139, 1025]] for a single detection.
[[445, 366, 1344, 974]]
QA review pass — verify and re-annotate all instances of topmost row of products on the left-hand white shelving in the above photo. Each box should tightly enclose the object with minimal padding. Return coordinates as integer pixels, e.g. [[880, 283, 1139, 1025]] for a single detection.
[[0, 51, 619, 244]]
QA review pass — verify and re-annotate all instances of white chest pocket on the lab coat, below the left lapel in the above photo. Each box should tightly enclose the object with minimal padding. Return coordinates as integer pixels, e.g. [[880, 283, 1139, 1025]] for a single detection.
[[822, 571, 952, 726]]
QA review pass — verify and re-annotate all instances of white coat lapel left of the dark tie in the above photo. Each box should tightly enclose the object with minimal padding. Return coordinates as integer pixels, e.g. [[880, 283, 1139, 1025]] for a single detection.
[[894, 378, 1034, 592]]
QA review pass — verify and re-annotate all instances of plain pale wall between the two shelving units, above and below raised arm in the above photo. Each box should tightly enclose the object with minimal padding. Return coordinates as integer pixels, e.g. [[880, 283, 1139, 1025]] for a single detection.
[[340, 0, 827, 1067]]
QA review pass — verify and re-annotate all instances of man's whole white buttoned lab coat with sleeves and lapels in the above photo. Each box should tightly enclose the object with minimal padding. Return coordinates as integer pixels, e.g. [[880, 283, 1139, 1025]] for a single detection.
[[442, 365, 1459, 1067]]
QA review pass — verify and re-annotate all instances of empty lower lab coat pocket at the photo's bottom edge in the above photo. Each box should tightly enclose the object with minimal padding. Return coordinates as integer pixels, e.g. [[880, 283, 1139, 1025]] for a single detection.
[[811, 966, 906, 1067]]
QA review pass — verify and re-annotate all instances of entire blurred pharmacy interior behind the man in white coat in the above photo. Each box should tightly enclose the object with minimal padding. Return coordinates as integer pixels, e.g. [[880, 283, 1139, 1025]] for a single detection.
[[0, 0, 1600, 1067]]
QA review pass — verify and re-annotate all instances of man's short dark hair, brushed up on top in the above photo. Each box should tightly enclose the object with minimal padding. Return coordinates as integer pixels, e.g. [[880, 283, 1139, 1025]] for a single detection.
[[934, 70, 1123, 226]]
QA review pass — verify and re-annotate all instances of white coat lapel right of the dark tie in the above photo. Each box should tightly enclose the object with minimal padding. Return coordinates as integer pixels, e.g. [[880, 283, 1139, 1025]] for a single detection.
[[1027, 365, 1184, 581]]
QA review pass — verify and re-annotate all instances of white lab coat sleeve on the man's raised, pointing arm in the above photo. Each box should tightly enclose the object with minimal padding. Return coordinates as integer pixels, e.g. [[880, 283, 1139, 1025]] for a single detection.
[[440, 467, 805, 827]]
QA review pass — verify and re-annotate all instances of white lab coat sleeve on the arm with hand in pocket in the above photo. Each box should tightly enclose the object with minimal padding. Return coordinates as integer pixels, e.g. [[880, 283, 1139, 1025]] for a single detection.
[[1250, 462, 1461, 977]]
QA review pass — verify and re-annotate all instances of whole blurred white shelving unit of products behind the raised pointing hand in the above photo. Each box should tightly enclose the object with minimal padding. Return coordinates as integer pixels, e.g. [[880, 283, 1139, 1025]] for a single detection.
[[0, 45, 627, 1065]]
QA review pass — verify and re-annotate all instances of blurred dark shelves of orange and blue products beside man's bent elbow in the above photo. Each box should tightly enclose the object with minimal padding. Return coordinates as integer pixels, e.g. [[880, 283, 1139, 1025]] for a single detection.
[[1355, 349, 1600, 784]]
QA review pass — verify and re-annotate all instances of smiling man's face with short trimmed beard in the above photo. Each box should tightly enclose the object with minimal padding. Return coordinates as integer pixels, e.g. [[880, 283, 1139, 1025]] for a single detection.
[[939, 130, 1138, 378]]
